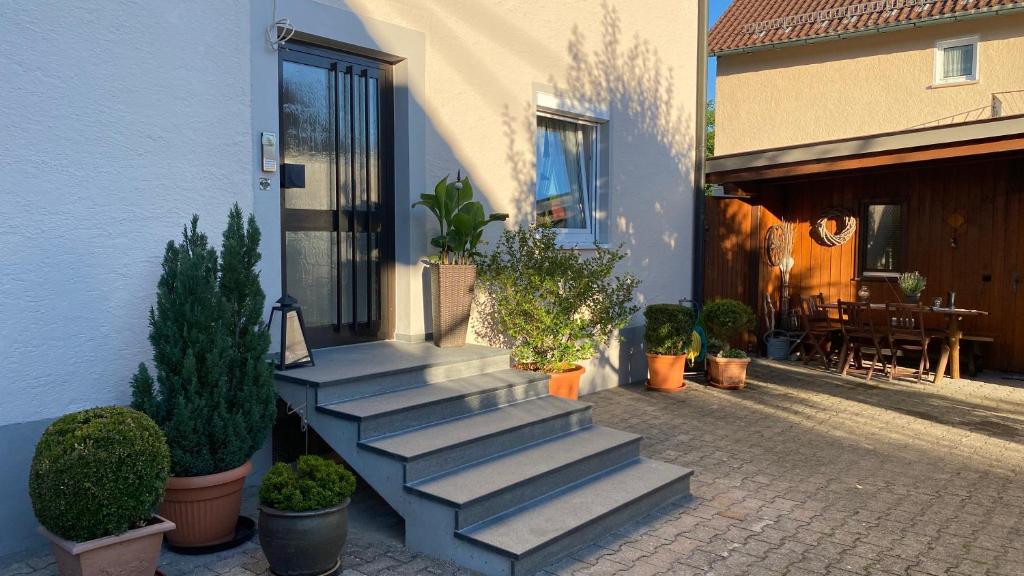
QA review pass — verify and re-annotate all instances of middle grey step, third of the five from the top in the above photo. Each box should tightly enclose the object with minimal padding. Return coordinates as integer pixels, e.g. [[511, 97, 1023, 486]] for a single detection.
[[359, 396, 591, 484]]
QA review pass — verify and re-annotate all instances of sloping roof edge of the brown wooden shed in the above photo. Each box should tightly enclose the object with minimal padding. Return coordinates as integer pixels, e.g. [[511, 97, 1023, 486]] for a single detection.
[[707, 115, 1024, 184]]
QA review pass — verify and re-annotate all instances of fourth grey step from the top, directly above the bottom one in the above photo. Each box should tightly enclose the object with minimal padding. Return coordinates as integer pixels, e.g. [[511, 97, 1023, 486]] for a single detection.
[[407, 426, 641, 529]]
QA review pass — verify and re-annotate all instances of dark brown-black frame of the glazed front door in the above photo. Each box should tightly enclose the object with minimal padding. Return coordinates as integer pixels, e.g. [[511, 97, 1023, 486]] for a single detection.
[[278, 42, 396, 347]]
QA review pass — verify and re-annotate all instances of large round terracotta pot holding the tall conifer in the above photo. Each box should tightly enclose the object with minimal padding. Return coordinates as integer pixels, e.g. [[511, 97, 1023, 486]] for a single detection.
[[160, 460, 253, 548]]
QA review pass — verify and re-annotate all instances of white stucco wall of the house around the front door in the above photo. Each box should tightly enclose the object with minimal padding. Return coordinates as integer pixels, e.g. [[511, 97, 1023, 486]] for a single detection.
[[0, 0, 696, 426]]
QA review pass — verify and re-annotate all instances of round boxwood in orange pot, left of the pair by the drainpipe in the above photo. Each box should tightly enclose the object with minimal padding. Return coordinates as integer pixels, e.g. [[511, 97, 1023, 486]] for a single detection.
[[643, 304, 696, 393]]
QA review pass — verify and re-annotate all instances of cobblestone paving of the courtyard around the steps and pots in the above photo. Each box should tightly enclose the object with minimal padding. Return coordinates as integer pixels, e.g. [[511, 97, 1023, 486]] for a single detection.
[[0, 361, 1024, 576]]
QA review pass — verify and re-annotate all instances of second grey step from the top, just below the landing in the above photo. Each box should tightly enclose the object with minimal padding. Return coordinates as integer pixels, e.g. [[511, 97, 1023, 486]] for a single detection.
[[318, 369, 548, 440]]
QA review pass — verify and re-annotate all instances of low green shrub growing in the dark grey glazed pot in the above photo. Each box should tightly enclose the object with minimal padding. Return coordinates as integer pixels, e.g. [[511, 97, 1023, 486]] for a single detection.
[[259, 455, 355, 512]]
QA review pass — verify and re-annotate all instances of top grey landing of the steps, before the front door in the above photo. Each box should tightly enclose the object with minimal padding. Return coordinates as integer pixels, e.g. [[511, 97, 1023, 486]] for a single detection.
[[274, 341, 511, 406]]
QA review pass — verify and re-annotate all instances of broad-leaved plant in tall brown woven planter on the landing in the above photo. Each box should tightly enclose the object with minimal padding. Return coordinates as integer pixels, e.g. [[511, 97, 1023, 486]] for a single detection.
[[413, 173, 509, 347]]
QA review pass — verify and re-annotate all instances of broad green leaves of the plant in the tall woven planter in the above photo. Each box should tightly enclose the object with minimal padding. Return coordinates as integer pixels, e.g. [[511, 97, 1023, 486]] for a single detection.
[[413, 176, 509, 264]]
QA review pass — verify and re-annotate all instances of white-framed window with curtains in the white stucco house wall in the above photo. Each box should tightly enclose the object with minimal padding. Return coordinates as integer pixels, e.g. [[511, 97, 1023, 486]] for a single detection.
[[534, 90, 607, 247]]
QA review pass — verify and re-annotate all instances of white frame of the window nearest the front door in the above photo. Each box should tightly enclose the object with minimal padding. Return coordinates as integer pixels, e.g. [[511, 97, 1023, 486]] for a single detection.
[[531, 92, 608, 248]]
